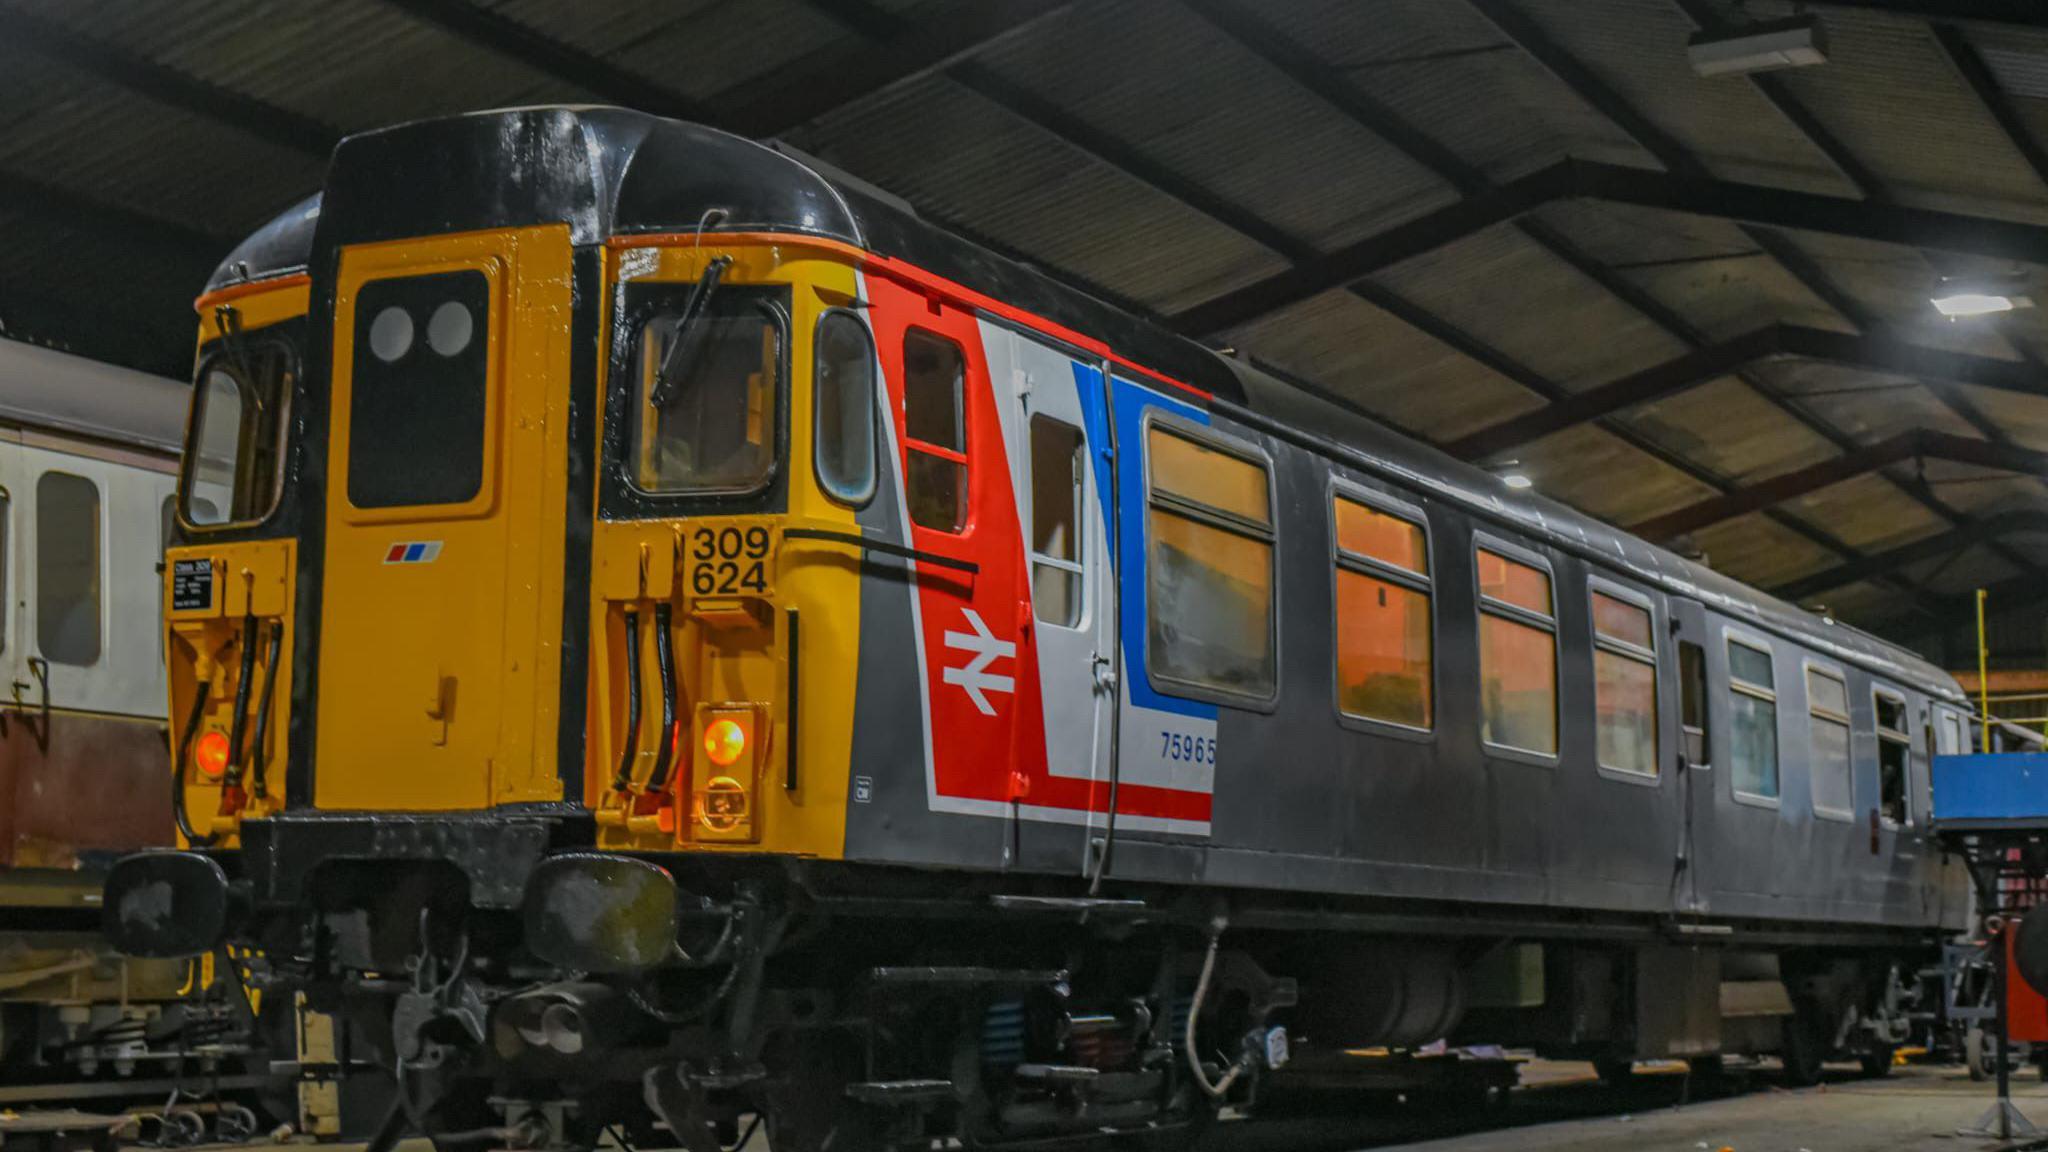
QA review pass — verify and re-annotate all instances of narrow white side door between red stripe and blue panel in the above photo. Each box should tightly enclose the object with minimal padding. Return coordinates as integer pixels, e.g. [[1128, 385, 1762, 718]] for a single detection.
[[983, 324, 1116, 871]]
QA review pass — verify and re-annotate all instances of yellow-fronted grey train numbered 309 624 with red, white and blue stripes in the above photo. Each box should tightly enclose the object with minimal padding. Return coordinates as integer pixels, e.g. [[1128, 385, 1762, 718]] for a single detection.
[[106, 109, 1970, 1150]]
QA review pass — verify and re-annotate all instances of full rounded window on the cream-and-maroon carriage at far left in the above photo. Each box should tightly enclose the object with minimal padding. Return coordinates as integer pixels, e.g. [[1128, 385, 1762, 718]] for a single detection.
[[35, 471, 100, 668]]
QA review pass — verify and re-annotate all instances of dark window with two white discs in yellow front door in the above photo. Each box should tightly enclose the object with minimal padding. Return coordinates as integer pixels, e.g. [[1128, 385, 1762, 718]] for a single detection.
[[348, 273, 489, 508]]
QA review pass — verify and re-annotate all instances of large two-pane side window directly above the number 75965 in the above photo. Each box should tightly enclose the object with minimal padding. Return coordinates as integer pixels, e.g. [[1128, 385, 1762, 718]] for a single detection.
[[1145, 424, 1276, 699]]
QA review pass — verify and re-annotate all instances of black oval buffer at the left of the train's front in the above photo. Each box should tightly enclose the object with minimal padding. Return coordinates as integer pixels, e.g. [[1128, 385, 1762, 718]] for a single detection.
[[100, 851, 229, 959]]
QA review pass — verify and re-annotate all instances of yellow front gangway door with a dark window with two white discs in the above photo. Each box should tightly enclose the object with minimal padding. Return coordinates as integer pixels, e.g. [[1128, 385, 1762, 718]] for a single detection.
[[313, 228, 571, 810]]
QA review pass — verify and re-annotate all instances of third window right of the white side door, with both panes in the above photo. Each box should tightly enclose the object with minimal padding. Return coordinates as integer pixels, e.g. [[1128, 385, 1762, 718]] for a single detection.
[[1479, 547, 1556, 756]]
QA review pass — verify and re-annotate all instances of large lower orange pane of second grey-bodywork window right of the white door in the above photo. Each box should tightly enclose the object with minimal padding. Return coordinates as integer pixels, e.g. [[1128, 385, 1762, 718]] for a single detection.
[[1337, 568, 1432, 728]]
